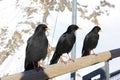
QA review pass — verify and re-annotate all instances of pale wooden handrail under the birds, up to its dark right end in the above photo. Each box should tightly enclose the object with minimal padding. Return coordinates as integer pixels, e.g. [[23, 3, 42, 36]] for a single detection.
[[1, 51, 111, 80]]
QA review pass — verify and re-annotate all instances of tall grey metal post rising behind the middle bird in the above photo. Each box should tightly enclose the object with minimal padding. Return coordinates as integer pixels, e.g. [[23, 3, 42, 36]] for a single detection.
[[71, 0, 77, 80]]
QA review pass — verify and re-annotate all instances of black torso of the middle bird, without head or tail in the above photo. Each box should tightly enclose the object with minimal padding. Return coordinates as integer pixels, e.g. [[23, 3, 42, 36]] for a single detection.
[[56, 33, 76, 53]]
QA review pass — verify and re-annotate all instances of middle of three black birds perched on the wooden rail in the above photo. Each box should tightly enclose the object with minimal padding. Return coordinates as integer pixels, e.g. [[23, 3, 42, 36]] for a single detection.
[[50, 25, 81, 64]]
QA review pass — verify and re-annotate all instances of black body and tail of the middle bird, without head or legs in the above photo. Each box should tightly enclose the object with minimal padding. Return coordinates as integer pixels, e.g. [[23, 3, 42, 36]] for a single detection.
[[50, 33, 75, 64]]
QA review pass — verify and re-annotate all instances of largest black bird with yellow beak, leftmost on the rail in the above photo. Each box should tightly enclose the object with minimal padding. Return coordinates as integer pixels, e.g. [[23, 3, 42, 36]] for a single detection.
[[24, 24, 49, 71]]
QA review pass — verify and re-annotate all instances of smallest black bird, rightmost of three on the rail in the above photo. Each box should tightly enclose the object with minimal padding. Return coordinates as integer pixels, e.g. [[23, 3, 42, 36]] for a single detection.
[[82, 26, 101, 57]]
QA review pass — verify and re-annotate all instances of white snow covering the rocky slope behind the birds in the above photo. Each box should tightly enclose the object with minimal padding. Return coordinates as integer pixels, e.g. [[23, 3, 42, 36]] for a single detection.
[[0, 0, 120, 80]]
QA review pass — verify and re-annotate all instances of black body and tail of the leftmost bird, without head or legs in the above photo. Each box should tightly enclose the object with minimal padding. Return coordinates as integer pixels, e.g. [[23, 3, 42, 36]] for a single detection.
[[25, 35, 48, 70]]
